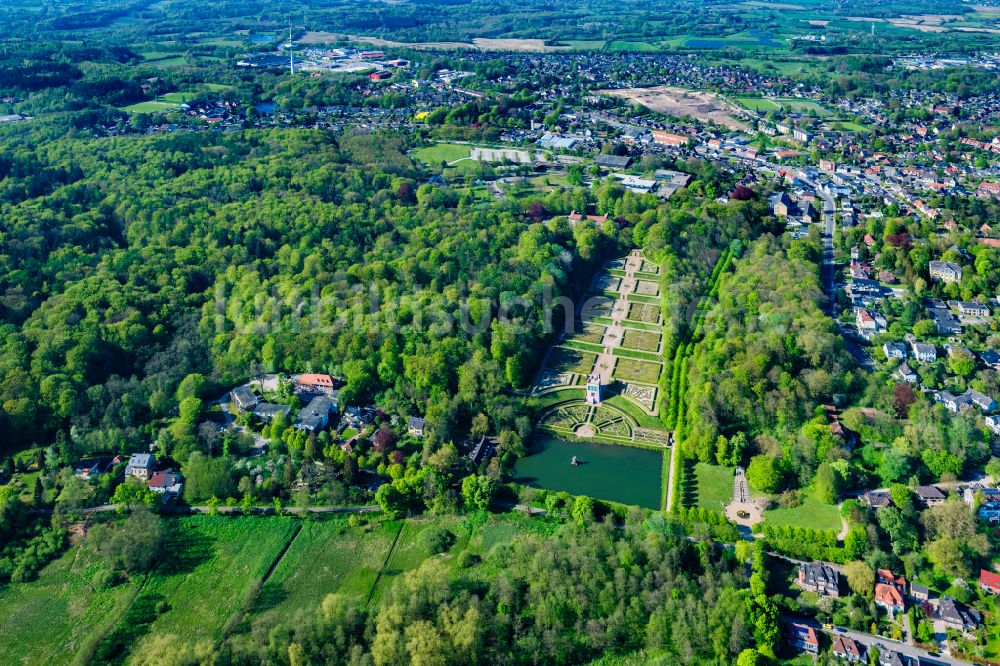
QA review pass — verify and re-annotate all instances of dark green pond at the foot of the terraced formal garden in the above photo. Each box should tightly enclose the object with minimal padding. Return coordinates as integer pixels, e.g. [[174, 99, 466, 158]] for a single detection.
[[514, 435, 663, 509]]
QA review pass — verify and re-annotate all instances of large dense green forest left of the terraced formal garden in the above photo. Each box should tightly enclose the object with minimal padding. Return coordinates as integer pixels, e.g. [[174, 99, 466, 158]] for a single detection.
[[0, 126, 615, 454]]
